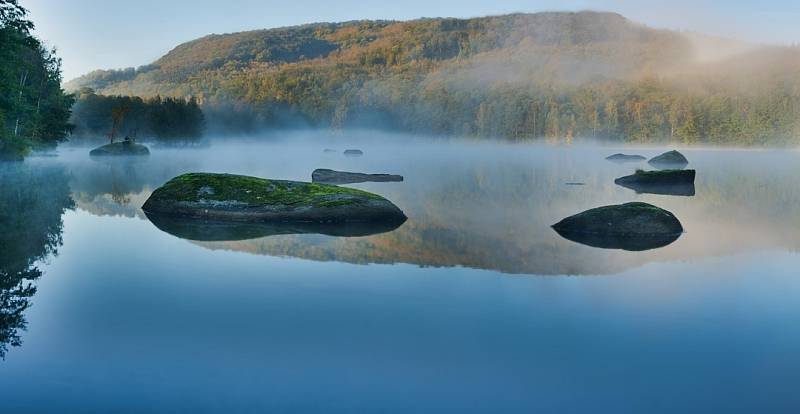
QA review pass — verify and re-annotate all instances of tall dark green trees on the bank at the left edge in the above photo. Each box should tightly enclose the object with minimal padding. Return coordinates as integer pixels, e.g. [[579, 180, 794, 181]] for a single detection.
[[0, 0, 73, 159]]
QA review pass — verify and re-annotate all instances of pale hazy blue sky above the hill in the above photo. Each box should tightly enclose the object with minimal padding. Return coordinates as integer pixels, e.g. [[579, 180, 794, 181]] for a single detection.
[[20, 0, 800, 80]]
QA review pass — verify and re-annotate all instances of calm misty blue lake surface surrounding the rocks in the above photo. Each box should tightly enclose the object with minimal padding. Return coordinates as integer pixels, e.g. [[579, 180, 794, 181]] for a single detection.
[[0, 133, 800, 413]]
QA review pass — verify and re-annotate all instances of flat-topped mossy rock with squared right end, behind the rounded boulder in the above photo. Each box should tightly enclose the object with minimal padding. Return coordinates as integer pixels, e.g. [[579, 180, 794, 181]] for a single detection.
[[614, 170, 696, 196]]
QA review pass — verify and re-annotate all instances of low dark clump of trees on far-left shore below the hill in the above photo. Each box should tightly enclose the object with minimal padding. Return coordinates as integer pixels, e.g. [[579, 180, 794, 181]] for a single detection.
[[72, 88, 205, 142]]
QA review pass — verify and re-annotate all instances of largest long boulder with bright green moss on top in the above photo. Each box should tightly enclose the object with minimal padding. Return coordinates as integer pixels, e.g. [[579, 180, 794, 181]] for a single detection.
[[142, 173, 406, 223]]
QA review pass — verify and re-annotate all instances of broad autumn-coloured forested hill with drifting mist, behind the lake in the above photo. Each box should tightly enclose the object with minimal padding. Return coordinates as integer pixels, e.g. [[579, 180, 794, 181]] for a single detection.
[[67, 12, 800, 145]]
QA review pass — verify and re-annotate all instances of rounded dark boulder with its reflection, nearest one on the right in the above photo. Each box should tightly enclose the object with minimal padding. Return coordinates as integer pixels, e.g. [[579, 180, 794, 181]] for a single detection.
[[553, 203, 683, 251]]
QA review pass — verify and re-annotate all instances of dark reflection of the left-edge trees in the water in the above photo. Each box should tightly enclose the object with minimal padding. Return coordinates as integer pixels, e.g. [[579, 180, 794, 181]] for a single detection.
[[0, 163, 74, 358]]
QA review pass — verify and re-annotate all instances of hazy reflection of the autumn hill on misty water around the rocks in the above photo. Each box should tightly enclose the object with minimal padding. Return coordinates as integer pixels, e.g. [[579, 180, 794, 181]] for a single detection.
[[51, 144, 800, 274]]
